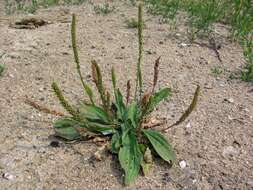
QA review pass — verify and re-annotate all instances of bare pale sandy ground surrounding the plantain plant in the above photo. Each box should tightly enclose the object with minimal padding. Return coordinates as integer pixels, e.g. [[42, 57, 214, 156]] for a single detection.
[[0, 1, 253, 190]]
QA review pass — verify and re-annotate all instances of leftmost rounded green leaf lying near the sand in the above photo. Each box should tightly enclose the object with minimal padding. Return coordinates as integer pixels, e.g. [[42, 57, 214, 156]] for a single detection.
[[53, 118, 81, 140]]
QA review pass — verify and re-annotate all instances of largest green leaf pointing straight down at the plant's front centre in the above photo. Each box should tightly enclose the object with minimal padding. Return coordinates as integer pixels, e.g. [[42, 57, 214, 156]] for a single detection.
[[119, 130, 142, 185]]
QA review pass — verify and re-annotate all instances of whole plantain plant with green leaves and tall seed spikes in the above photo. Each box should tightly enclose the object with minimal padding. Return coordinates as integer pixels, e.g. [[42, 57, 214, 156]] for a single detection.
[[27, 3, 199, 185]]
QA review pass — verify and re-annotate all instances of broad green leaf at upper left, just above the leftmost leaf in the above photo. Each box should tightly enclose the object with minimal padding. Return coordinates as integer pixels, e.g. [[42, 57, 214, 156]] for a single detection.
[[79, 105, 110, 124]]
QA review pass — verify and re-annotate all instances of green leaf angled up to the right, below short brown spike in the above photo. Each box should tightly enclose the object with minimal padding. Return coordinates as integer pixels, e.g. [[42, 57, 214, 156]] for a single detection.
[[143, 88, 171, 115]]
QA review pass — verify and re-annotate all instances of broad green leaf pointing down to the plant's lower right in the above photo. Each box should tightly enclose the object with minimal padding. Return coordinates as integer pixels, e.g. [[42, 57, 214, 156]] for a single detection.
[[142, 129, 176, 163]]
